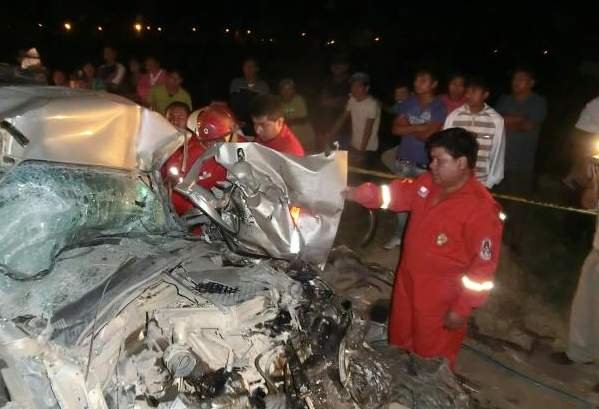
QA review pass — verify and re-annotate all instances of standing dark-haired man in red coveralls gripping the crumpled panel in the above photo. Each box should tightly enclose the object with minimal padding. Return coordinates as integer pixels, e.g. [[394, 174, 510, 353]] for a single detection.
[[348, 128, 503, 368]]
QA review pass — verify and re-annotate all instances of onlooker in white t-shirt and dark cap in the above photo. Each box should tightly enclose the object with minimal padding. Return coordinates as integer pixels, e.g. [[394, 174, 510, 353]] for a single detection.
[[328, 72, 381, 163]]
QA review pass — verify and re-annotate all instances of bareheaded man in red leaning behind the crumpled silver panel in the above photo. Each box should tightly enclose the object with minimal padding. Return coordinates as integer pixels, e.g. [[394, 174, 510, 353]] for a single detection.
[[250, 95, 304, 156]]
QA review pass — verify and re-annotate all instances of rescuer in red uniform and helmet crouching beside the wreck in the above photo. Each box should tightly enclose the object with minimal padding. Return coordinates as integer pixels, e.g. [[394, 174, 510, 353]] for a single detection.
[[161, 104, 242, 216]]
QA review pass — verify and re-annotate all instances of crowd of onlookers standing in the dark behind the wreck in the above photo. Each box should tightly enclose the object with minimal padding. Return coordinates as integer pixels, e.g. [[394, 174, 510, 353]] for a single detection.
[[27, 47, 556, 206]]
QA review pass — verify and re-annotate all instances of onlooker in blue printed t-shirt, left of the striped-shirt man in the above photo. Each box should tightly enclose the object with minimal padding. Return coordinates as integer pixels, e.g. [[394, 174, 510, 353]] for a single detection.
[[383, 69, 445, 250]]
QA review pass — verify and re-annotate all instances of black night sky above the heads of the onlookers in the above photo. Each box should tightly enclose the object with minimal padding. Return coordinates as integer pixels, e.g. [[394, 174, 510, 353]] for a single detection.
[[0, 0, 599, 173]]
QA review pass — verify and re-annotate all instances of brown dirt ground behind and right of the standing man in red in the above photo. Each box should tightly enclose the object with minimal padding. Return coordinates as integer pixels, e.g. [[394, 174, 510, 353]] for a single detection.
[[336, 180, 599, 409]]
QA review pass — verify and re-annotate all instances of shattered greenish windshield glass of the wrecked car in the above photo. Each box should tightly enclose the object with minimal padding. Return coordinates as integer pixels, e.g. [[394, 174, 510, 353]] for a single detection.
[[0, 161, 170, 285]]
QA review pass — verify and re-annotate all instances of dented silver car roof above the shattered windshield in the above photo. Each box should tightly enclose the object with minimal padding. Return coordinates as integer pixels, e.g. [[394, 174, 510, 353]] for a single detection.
[[0, 86, 184, 171]]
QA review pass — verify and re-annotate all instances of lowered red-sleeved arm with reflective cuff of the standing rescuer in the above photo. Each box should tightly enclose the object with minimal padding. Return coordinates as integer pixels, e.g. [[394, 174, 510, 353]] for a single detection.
[[445, 205, 503, 329]]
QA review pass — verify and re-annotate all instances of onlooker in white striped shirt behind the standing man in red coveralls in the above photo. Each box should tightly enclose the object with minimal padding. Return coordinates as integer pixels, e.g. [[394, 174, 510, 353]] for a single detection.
[[444, 78, 505, 189]]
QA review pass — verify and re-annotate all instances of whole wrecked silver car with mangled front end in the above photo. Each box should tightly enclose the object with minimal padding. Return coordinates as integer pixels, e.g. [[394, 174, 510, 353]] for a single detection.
[[0, 87, 469, 409]]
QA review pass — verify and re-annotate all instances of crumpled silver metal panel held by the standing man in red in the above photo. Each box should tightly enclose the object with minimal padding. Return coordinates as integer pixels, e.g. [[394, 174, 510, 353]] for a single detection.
[[176, 143, 347, 264]]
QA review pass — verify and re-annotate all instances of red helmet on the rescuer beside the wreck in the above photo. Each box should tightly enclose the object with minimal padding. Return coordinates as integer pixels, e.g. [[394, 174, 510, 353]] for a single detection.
[[187, 104, 239, 141]]
